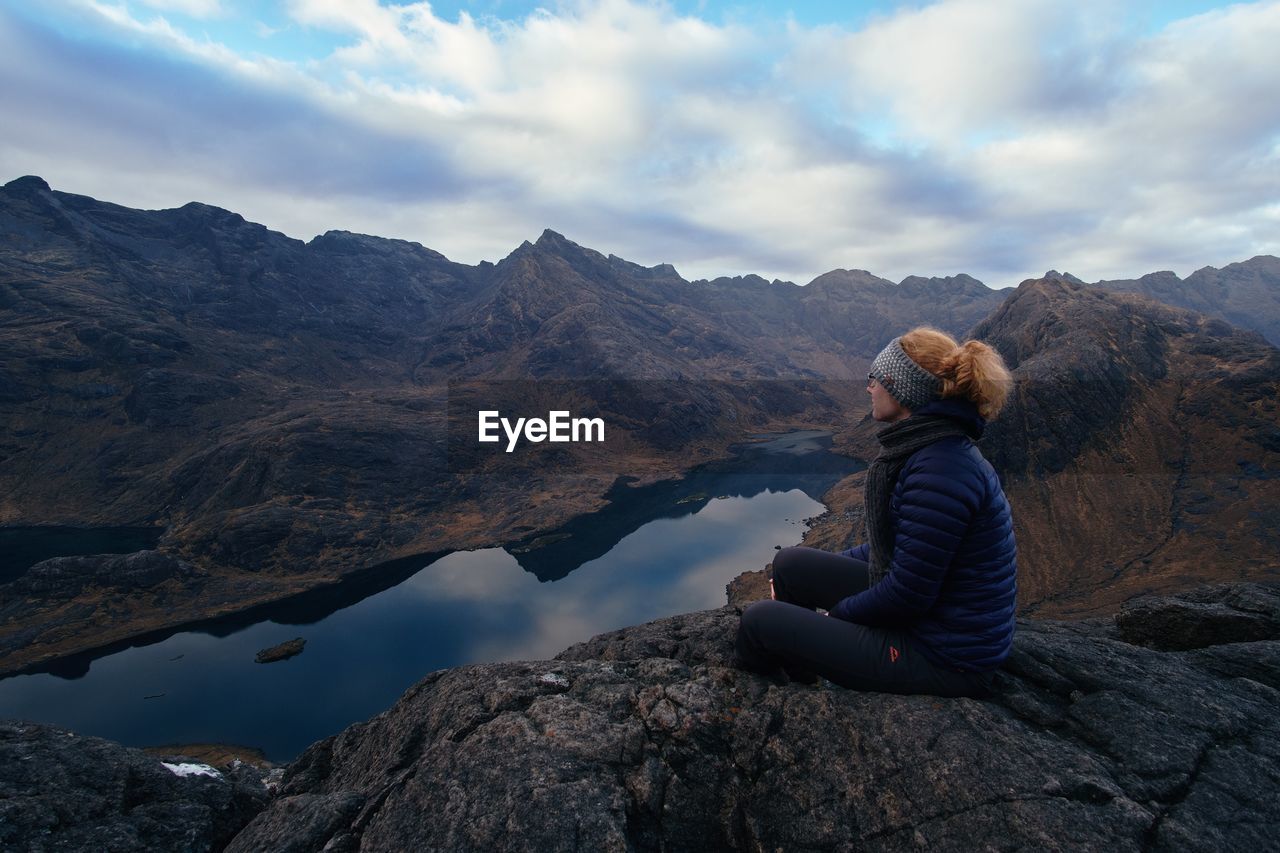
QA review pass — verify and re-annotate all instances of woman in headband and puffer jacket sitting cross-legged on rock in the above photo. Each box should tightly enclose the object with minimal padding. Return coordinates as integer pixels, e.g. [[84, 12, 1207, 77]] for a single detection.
[[737, 328, 1016, 695]]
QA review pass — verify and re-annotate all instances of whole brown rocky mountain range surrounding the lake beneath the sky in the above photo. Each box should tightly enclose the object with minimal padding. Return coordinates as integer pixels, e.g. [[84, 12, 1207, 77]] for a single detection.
[[0, 177, 1280, 671]]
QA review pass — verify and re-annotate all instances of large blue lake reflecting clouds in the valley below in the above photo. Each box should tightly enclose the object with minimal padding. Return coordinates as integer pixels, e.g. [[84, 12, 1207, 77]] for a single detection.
[[0, 433, 856, 761]]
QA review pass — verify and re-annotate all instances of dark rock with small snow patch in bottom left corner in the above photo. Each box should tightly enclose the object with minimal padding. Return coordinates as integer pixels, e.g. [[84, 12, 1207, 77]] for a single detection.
[[0, 721, 268, 853]]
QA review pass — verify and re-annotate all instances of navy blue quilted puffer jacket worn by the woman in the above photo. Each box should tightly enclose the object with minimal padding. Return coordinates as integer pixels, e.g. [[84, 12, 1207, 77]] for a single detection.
[[831, 398, 1018, 671]]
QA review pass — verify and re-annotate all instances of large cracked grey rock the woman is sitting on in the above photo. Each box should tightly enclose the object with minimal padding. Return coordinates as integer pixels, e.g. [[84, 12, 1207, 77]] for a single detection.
[[229, 588, 1280, 850]]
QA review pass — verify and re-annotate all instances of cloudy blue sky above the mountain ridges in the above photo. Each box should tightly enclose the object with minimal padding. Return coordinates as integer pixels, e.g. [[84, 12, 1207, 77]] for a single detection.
[[0, 0, 1280, 287]]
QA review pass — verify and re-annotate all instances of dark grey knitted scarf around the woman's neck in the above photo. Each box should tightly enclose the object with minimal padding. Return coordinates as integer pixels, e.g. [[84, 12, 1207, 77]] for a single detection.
[[863, 415, 970, 587]]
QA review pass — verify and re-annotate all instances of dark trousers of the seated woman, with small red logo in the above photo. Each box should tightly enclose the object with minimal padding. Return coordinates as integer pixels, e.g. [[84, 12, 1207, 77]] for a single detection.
[[737, 547, 991, 697]]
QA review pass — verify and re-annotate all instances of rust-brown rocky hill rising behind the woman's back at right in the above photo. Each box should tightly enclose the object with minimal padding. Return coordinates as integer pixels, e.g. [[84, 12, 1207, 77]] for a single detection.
[[806, 277, 1280, 617]]
